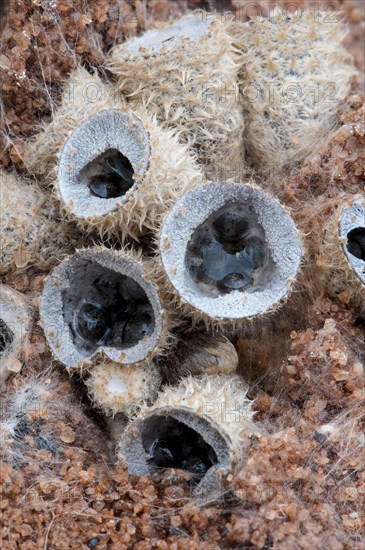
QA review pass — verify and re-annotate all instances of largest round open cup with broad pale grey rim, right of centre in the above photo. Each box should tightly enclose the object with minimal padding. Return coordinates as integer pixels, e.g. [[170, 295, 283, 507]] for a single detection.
[[159, 183, 301, 327]]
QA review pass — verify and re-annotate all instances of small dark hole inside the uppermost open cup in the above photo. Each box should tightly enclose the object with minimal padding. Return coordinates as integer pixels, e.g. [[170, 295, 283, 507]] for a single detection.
[[78, 149, 134, 199]]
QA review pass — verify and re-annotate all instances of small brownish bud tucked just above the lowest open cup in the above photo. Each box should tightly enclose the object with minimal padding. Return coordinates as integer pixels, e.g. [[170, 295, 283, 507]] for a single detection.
[[158, 331, 238, 384]]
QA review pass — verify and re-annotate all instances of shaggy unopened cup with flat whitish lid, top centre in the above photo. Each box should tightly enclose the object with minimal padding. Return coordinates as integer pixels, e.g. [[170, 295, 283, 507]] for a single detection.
[[110, 13, 244, 179]]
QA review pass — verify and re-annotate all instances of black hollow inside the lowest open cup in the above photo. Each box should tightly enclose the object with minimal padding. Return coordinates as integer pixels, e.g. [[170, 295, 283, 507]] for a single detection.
[[142, 414, 218, 478]]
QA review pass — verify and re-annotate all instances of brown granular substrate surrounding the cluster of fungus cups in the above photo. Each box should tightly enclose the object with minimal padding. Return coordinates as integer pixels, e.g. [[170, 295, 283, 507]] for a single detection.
[[0, 0, 365, 550]]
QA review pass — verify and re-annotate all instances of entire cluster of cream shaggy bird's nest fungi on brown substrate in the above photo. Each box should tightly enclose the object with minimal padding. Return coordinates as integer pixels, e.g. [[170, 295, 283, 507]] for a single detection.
[[1, 7, 364, 500]]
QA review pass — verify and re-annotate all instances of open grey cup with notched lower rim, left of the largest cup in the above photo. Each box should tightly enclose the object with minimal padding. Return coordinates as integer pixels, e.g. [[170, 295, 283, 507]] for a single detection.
[[40, 247, 170, 369]]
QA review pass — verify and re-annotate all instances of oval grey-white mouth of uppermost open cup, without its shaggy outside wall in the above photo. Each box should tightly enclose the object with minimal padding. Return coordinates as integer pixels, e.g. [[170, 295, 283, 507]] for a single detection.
[[58, 109, 150, 226]]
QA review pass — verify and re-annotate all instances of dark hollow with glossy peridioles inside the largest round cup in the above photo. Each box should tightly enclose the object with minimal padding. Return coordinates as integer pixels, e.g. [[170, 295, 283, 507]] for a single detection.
[[185, 203, 275, 295]]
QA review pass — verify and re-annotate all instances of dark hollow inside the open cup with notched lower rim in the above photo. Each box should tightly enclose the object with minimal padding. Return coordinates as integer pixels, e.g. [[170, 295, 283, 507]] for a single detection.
[[62, 261, 155, 354]]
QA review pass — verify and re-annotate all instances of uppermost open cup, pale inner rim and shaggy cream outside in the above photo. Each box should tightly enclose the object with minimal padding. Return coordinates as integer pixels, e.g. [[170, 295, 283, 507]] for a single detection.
[[57, 109, 201, 239]]
